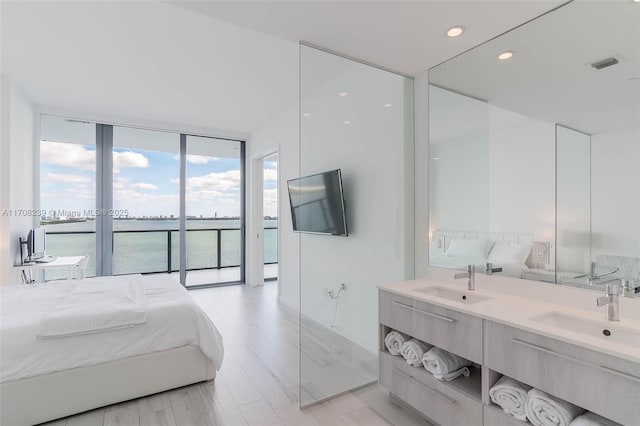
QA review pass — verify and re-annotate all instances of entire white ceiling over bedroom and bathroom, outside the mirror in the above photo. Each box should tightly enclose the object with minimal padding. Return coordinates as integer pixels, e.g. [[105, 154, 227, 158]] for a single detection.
[[0, 0, 562, 133]]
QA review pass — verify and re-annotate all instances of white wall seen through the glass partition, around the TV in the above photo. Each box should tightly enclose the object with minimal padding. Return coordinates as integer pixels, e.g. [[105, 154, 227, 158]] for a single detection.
[[300, 48, 414, 353]]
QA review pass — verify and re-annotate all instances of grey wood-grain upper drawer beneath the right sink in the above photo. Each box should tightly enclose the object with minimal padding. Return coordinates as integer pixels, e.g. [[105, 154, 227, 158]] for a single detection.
[[484, 321, 640, 425]]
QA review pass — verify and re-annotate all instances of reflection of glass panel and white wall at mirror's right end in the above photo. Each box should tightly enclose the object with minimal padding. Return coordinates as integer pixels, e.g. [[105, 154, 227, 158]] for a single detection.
[[557, 126, 640, 295]]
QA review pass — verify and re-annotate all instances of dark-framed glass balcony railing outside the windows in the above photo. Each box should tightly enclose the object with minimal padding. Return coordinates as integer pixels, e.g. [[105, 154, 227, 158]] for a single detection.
[[47, 227, 278, 275]]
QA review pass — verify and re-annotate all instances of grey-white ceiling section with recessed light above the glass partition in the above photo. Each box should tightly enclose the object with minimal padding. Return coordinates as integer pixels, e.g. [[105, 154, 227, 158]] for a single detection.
[[168, 0, 564, 76]]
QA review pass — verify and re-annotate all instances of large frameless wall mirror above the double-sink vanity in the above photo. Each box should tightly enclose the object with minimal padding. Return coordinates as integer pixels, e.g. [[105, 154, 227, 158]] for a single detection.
[[429, 0, 640, 290]]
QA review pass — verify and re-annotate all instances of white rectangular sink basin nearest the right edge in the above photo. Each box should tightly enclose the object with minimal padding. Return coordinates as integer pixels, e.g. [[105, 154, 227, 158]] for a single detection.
[[529, 311, 640, 348]]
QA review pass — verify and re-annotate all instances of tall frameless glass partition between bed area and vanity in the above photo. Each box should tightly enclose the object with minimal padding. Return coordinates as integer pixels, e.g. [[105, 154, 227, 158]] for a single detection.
[[298, 45, 414, 407]]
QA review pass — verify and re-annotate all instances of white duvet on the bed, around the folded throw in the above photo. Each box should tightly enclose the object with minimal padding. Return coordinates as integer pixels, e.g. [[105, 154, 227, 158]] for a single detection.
[[0, 275, 224, 383]]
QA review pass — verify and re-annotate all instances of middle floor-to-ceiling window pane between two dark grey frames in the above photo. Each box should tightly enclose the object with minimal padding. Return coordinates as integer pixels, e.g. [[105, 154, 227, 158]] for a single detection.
[[112, 126, 180, 275]]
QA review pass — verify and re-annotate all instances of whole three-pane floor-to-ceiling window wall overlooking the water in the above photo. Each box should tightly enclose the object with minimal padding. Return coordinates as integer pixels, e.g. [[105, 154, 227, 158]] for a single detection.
[[40, 115, 244, 287]]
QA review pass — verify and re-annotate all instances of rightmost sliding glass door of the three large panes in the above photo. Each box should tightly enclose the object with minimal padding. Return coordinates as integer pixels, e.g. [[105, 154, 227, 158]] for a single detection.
[[185, 136, 244, 287]]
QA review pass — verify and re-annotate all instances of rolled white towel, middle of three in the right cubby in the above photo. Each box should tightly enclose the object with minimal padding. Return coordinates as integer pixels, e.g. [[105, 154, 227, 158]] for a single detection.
[[526, 389, 584, 426]]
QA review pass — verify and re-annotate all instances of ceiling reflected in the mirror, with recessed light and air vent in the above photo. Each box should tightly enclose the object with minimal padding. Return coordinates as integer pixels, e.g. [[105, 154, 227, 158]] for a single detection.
[[429, 0, 640, 134]]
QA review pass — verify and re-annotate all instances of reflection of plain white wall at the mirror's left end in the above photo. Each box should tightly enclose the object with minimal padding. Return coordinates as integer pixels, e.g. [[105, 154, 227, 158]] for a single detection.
[[429, 86, 489, 269]]
